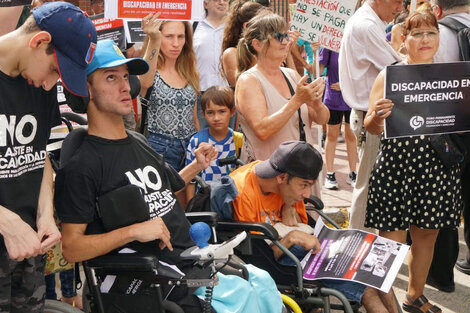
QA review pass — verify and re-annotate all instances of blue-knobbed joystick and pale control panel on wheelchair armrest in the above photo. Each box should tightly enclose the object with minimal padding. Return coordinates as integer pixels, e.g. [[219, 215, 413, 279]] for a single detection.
[[180, 222, 246, 262]]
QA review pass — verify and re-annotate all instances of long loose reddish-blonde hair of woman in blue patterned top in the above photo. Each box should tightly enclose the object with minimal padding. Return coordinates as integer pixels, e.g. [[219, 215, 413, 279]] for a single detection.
[[157, 21, 199, 93]]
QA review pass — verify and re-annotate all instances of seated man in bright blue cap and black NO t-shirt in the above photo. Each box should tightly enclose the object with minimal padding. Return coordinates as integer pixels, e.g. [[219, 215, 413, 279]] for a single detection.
[[55, 41, 282, 312]]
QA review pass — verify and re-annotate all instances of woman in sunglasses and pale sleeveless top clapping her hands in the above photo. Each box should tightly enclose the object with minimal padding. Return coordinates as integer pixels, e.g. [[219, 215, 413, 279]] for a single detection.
[[235, 13, 330, 161]]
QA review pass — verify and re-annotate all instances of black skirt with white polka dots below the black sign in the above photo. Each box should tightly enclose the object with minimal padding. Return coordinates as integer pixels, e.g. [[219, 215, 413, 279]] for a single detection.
[[365, 136, 463, 231]]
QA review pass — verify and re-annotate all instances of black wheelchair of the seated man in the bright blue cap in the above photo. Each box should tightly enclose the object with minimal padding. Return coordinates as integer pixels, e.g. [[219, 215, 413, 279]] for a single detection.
[[46, 106, 288, 313]]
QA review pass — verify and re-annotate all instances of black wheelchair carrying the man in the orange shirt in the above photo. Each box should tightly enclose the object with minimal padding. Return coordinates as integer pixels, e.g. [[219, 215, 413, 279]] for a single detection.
[[191, 161, 401, 313]]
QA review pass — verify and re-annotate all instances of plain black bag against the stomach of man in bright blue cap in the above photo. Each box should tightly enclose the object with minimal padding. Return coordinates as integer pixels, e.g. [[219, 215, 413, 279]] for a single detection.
[[96, 184, 150, 232]]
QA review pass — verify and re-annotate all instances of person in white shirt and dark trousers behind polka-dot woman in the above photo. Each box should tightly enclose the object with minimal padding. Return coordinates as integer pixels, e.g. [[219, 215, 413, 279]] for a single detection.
[[427, 0, 470, 292]]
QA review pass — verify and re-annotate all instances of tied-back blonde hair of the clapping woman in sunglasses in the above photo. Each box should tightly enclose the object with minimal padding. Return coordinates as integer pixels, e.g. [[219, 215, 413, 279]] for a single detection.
[[237, 12, 287, 78]]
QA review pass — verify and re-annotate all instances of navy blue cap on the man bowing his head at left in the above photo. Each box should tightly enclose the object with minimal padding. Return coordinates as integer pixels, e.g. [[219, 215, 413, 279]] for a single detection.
[[33, 2, 97, 97]]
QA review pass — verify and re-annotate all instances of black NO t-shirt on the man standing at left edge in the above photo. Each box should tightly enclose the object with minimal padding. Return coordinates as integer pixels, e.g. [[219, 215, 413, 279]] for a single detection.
[[0, 71, 60, 247]]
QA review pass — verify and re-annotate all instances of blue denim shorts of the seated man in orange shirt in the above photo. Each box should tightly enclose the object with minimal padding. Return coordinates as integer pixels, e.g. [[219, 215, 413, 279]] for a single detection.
[[278, 245, 366, 303]]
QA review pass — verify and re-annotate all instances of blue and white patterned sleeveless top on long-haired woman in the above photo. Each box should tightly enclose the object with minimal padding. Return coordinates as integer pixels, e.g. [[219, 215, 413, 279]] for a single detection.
[[148, 71, 197, 139]]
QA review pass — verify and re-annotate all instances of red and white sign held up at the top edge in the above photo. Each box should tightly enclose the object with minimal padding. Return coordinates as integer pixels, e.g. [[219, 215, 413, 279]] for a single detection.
[[104, 0, 204, 21]]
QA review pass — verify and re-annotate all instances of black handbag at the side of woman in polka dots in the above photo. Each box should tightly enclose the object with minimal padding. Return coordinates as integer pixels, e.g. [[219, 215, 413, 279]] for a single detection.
[[429, 134, 467, 169]]
